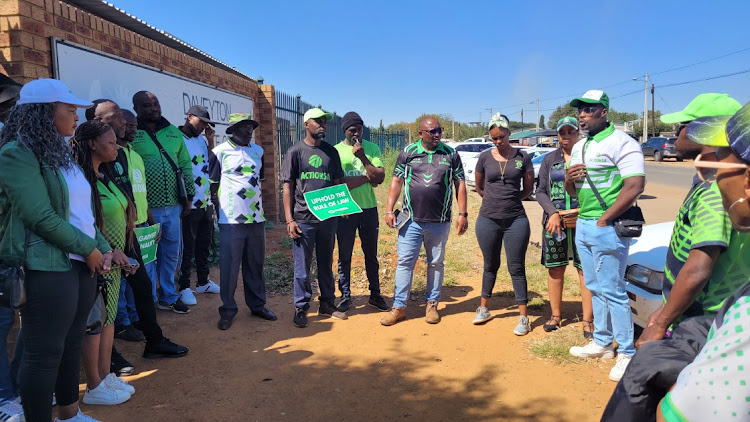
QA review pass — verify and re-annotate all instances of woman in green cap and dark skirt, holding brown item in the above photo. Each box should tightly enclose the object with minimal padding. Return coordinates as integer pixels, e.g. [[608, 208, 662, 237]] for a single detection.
[[536, 117, 594, 338]]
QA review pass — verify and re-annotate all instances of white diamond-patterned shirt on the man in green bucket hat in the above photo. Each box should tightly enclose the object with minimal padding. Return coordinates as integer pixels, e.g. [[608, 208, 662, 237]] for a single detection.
[[209, 140, 266, 224]]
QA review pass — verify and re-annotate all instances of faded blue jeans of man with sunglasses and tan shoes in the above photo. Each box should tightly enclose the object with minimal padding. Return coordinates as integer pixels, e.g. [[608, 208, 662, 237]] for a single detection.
[[393, 220, 451, 308]]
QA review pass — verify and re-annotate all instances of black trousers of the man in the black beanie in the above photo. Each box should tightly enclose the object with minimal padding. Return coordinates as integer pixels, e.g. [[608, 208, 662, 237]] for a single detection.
[[336, 208, 380, 296]]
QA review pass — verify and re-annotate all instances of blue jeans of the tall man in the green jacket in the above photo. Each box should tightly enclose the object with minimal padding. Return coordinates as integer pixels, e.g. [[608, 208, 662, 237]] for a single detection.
[[146, 205, 182, 304]]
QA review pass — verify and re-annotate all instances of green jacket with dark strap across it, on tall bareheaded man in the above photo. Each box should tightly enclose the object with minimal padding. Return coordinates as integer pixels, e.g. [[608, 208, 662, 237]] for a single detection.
[[130, 117, 195, 208]]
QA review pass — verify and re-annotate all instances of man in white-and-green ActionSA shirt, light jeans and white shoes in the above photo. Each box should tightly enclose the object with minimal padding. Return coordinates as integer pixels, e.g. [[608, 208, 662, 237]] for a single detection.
[[565, 90, 646, 382]]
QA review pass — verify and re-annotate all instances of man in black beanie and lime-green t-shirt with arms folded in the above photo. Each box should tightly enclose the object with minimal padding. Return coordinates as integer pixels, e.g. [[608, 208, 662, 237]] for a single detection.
[[335, 111, 389, 312]]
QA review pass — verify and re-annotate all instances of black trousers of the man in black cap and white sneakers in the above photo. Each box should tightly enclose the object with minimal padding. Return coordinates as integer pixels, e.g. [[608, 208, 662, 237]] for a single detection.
[[178, 208, 214, 291]]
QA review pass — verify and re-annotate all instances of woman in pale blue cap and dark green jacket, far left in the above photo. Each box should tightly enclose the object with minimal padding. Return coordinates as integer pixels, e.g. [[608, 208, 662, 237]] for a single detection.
[[0, 79, 112, 422]]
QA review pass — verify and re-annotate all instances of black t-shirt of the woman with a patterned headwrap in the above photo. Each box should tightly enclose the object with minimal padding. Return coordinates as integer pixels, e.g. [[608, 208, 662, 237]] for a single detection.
[[475, 148, 534, 219]]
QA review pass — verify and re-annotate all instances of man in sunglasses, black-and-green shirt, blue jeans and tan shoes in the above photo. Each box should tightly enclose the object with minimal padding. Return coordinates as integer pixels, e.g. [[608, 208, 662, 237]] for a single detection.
[[380, 117, 468, 326]]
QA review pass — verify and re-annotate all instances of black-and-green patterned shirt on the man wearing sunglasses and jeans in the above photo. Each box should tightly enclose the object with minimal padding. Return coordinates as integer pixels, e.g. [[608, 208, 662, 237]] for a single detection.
[[393, 141, 464, 223]]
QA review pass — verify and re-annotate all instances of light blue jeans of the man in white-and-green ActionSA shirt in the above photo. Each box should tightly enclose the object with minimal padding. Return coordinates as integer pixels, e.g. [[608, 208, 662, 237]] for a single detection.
[[576, 218, 635, 356]]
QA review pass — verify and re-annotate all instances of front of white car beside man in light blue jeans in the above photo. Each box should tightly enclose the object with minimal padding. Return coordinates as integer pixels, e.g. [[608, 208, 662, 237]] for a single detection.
[[625, 221, 674, 328]]
